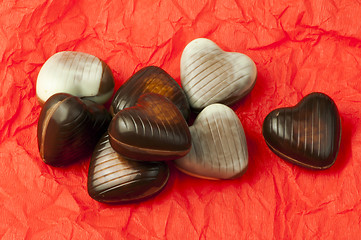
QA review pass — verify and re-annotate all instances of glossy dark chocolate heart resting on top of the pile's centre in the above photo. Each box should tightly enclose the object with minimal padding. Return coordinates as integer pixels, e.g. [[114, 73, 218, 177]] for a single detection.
[[108, 93, 191, 161]]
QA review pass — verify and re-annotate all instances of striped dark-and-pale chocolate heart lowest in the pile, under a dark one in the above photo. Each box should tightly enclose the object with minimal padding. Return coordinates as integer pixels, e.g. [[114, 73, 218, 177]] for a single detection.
[[88, 134, 169, 203]]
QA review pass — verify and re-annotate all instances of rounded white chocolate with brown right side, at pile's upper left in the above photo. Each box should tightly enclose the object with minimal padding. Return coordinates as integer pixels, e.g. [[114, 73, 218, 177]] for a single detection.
[[36, 51, 114, 103]]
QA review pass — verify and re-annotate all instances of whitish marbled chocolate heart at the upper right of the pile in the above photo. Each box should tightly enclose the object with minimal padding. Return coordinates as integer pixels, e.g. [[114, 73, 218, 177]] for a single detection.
[[180, 38, 257, 110]]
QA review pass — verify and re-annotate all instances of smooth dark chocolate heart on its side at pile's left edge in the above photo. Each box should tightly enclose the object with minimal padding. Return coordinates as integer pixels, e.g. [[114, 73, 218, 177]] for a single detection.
[[37, 93, 111, 166]]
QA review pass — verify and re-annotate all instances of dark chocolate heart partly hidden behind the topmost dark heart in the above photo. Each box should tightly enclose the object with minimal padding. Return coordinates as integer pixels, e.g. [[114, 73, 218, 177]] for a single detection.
[[110, 66, 190, 119]]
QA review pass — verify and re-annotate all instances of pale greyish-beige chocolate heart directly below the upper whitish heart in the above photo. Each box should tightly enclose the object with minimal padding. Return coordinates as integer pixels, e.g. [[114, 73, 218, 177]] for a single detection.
[[175, 103, 248, 179]]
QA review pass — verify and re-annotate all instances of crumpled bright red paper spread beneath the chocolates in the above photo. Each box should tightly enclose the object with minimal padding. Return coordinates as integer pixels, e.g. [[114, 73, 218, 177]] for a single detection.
[[0, 0, 361, 239]]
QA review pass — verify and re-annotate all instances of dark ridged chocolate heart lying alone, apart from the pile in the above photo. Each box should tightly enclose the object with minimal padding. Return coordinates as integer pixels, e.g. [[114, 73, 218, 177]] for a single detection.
[[262, 93, 341, 169]]
